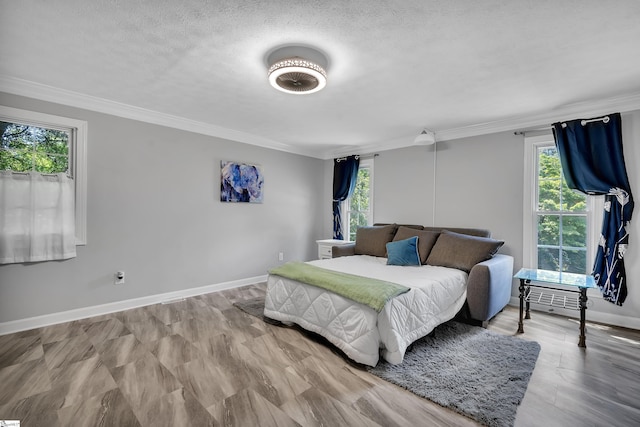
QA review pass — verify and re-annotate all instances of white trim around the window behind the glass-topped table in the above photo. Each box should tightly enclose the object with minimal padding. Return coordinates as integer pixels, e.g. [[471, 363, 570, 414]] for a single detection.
[[522, 134, 604, 298]]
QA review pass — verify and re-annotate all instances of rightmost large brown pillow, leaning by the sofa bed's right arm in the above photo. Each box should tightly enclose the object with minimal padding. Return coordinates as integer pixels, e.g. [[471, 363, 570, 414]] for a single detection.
[[427, 230, 504, 273]]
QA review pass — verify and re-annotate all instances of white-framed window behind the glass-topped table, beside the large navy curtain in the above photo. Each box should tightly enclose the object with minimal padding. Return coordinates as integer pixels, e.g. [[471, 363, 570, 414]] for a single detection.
[[523, 135, 602, 274]]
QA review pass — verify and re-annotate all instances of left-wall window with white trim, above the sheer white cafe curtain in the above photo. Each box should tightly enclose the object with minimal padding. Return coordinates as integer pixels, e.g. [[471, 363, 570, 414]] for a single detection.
[[0, 106, 87, 245]]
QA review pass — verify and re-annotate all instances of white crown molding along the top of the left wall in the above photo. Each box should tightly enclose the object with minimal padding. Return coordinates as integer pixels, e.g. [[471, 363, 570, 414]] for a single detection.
[[0, 75, 320, 157]]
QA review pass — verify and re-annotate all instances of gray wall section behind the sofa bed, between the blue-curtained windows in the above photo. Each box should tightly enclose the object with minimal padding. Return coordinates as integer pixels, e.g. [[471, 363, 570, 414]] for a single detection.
[[324, 132, 524, 263]]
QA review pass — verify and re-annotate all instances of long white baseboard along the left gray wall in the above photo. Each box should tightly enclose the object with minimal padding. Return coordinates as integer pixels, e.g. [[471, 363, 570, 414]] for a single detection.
[[0, 275, 267, 335]]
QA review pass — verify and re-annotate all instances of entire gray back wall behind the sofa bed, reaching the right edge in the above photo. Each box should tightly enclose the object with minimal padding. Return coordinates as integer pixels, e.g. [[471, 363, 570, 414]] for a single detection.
[[324, 111, 640, 328]]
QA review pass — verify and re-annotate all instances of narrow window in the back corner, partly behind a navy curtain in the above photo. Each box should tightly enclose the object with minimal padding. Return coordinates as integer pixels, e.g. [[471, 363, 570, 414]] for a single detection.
[[342, 159, 373, 242]]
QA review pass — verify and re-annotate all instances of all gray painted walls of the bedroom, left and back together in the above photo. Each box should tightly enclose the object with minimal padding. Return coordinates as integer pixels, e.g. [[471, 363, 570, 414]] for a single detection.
[[0, 89, 640, 332]]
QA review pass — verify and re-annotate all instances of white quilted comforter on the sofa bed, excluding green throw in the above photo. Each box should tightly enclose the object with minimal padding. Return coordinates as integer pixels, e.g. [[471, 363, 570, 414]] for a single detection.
[[264, 255, 467, 366]]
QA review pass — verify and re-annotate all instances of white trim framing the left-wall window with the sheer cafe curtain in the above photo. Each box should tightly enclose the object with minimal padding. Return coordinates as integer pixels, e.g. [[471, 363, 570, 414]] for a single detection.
[[0, 105, 88, 245]]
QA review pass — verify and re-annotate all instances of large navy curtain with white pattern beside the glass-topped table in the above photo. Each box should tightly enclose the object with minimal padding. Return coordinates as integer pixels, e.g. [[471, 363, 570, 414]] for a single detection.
[[553, 113, 634, 305]]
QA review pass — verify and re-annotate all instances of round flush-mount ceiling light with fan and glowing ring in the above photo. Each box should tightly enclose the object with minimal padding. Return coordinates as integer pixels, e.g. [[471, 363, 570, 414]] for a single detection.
[[267, 46, 327, 95]]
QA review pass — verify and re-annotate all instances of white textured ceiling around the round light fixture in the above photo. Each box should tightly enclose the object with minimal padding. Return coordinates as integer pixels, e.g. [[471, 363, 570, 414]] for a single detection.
[[0, 0, 640, 157]]
